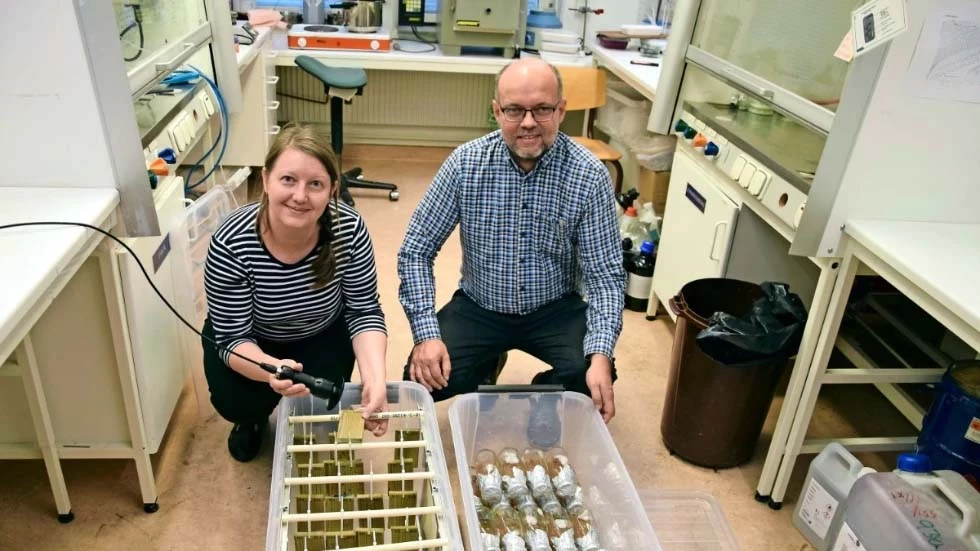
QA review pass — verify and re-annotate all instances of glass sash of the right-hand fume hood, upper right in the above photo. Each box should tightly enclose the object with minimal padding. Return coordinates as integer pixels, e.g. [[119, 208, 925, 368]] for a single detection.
[[692, 0, 864, 111]]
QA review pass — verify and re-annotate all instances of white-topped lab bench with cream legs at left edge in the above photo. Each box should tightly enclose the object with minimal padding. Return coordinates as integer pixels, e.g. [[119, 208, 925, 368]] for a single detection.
[[0, 187, 157, 522]]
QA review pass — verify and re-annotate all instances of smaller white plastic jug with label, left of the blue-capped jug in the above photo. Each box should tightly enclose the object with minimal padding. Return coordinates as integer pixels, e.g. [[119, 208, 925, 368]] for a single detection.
[[793, 442, 874, 551]]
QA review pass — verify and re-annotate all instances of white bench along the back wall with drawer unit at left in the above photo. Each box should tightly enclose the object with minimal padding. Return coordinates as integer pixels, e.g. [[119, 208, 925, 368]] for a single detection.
[[222, 27, 510, 166]]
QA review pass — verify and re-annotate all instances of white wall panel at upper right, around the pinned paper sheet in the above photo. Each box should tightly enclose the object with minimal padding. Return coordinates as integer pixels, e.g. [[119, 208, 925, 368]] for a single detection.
[[811, 1, 980, 254]]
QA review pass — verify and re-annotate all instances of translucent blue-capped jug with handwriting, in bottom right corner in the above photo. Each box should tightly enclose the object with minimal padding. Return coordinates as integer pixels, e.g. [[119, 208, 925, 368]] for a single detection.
[[831, 473, 980, 551]]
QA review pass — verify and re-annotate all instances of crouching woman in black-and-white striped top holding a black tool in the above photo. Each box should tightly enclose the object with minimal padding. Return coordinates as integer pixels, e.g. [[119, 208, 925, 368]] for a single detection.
[[202, 126, 387, 462]]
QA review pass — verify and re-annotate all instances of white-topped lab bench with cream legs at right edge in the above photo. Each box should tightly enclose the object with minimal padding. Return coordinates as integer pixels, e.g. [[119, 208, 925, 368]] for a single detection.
[[772, 220, 980, 502]]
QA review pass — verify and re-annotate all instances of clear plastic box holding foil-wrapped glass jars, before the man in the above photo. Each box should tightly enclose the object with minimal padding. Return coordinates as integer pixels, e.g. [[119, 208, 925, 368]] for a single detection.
[[449, 392, 662, 551]]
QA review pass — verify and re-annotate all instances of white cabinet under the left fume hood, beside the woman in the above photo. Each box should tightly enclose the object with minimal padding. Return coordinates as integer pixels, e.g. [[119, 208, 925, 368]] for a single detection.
[[0, 177, 200, 458]]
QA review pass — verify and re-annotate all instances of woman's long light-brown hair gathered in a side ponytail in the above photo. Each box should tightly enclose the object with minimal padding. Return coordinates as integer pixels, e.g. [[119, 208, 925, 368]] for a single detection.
[[257, 124, 340, 289]]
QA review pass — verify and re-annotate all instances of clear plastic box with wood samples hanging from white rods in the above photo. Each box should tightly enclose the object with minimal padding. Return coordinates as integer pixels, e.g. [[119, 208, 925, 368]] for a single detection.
[[266, 382, 463, 551]]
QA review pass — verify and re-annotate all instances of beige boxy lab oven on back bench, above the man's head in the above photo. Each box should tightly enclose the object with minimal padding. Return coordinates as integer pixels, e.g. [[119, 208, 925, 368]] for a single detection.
[[439, 0, 527, 58]]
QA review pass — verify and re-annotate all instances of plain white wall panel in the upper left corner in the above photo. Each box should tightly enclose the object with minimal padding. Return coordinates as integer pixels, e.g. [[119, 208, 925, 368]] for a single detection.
[[0, 0, 115, 187]]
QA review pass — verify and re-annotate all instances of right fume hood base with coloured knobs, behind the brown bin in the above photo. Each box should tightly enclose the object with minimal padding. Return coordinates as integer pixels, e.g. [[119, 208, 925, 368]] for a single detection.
[[647, 81, 825, 317]]
